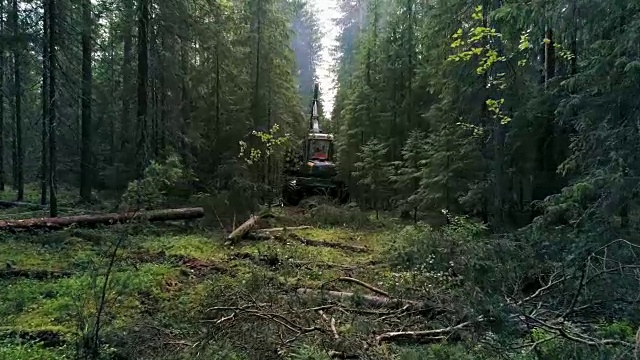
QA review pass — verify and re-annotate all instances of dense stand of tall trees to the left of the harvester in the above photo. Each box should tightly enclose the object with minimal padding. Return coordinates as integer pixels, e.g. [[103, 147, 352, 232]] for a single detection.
[[0, 0, 320, 214]]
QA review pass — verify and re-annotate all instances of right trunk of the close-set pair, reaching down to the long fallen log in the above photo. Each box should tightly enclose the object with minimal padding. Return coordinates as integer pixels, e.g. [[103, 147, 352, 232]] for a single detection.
[[48, 0, 58, 217]]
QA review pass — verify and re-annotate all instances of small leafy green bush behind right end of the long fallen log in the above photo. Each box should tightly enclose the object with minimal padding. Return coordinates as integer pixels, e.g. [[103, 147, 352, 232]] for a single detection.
[[121, 156, 188, 211]]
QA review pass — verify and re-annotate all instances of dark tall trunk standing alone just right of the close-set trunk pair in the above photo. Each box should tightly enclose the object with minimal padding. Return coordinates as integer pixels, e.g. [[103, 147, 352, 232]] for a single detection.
[[80, 0, 95, 202]]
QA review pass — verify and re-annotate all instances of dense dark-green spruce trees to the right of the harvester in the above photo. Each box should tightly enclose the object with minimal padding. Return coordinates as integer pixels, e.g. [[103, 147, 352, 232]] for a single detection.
[[333, 0, 640, 232]]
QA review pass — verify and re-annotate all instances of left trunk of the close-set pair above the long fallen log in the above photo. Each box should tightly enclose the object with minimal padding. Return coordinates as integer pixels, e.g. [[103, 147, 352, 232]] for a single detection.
[[40, 0, 49, 205]]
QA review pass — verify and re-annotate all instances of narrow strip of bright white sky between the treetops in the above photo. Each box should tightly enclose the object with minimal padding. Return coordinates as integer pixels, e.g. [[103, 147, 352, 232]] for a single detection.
[[309, 0, 339, 117]]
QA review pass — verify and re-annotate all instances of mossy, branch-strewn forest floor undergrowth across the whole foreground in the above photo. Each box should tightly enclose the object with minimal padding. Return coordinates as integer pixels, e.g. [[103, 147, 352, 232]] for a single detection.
[[0, 198, 638, 360]]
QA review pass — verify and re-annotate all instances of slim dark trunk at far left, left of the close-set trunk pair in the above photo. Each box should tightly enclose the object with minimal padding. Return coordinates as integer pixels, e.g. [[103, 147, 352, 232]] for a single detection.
[[13, 0, 24, 201]]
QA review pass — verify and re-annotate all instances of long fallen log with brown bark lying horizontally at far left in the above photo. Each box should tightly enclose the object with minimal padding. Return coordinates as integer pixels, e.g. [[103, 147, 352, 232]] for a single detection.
[[0, 207, 204, 231]]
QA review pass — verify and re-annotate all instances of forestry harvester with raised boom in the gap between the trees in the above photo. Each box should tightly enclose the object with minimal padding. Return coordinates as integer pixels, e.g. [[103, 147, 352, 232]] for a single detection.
[[283, 84, 348, 206]]
